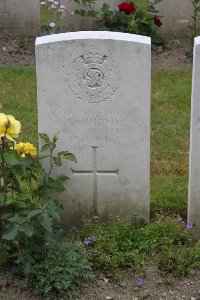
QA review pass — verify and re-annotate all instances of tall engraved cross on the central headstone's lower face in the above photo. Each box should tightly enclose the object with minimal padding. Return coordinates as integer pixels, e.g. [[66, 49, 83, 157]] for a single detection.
[[71, 146, 119, 215]]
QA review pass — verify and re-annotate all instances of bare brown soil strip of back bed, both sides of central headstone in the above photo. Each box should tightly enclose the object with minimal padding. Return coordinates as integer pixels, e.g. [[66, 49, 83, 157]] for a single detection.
[[0, 35, 191, 70]]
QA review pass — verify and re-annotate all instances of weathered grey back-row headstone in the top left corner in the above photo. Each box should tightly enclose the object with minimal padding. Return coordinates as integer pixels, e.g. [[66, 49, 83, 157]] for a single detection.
[[0, 0, 40, 36]]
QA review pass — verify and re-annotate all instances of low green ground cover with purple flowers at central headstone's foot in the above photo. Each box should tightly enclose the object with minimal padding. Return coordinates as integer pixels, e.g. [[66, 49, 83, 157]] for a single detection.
[[72, 218, 191, 274]]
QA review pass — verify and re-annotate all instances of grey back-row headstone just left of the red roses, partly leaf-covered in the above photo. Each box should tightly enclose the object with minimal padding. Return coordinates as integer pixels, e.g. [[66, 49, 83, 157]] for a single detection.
[[61, 0, 117, 32]]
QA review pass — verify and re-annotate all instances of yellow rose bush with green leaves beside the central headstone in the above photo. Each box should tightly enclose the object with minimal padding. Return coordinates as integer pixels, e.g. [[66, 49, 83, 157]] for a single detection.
[[0, 113, 76, 275]]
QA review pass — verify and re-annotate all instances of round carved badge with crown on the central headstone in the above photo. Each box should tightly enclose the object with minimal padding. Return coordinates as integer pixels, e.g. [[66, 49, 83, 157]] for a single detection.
[[67, 48, 120, 103]]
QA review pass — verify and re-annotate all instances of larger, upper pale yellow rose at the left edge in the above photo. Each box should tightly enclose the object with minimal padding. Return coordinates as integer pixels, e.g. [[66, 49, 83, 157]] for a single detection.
[[0, 113, 21, 142]]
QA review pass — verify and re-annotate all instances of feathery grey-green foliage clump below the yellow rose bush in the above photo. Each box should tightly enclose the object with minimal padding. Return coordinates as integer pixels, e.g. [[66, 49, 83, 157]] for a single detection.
[[32, 241, 92, 299]]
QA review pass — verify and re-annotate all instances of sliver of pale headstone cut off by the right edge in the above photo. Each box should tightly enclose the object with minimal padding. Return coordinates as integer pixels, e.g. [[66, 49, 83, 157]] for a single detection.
[[188, 37, 200, 229]]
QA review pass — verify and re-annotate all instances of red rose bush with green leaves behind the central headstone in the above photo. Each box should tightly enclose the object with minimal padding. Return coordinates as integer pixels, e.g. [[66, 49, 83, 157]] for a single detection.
[[74, 0, 162, 44]]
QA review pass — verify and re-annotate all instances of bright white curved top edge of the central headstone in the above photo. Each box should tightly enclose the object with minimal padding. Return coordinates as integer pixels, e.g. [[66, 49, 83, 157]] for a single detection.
[[35, 31, 151, 46]]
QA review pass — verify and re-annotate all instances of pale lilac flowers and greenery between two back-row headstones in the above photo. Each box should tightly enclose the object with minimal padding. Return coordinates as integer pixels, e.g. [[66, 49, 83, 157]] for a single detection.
[[40, 0, 66, 35]]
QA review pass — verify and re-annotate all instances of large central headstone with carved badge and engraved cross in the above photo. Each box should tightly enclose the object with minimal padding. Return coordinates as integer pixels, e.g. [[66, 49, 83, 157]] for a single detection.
[[36, 32, 151, 227]]
